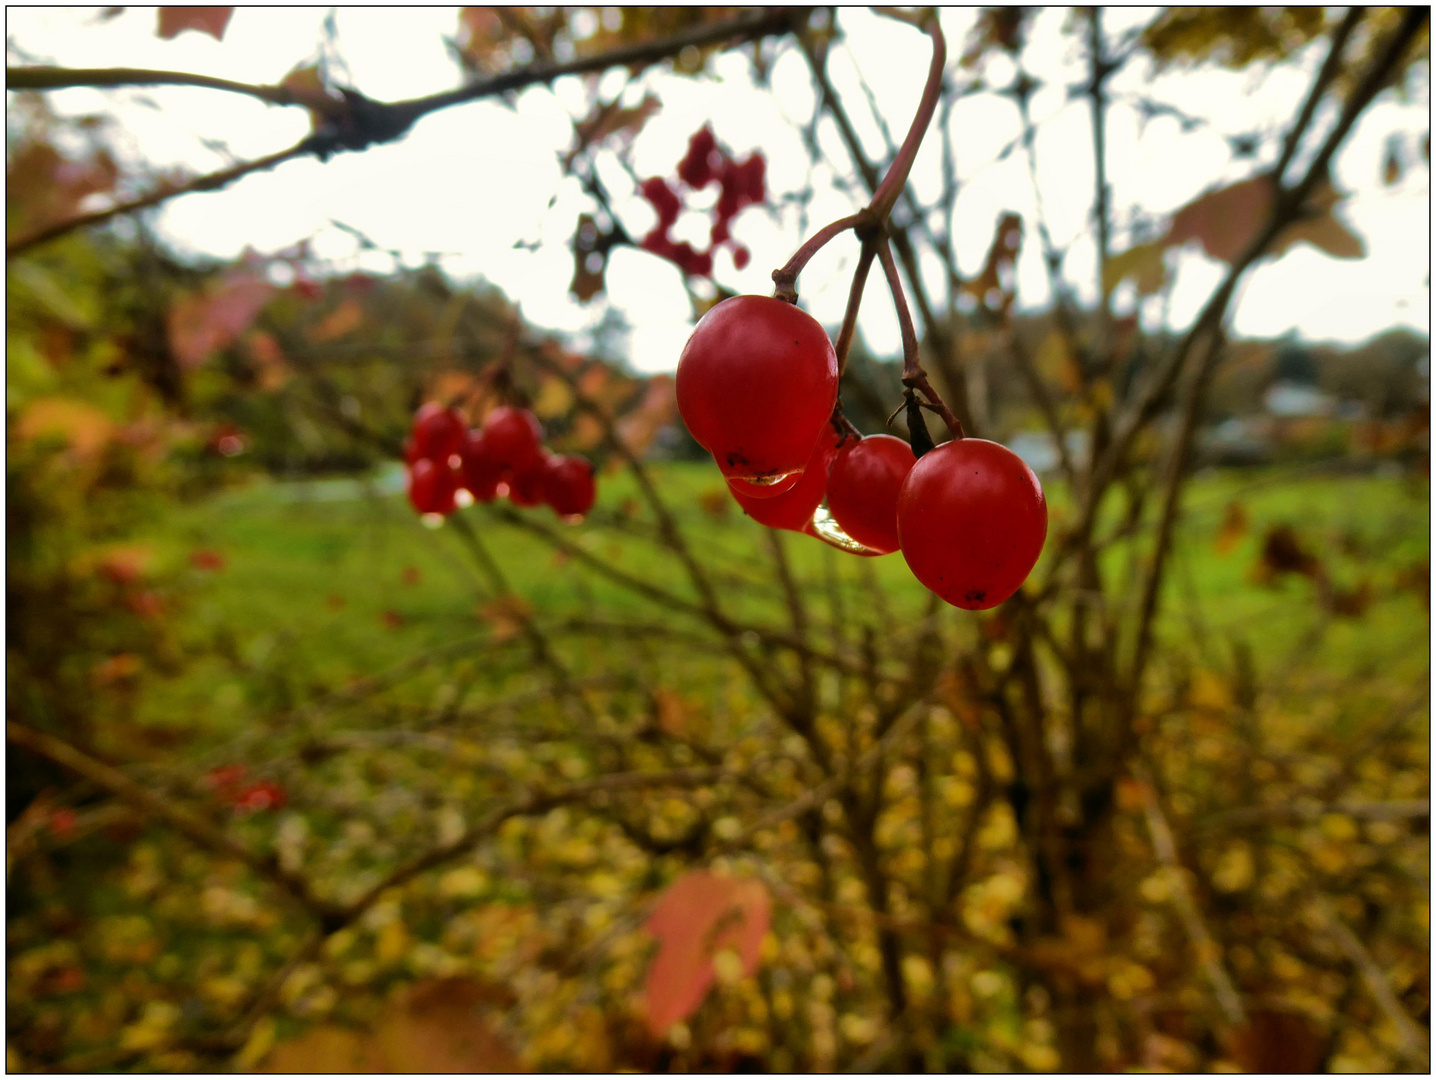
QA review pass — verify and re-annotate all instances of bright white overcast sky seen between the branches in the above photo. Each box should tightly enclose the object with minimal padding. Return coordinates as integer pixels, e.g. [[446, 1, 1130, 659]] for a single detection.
[[7, 7, 1430, 371]]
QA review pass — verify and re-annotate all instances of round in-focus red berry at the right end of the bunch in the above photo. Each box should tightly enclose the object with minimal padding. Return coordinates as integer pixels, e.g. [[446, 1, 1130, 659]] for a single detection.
[[898, 438, 1047, 610]]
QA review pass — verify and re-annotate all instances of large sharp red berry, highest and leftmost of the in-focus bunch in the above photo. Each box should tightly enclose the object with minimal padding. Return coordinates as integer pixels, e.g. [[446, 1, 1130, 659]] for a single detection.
[[676, 296, 837, 483]]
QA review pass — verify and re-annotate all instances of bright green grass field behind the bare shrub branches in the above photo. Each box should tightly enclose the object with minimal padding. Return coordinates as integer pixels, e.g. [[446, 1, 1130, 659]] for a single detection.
[[132, 464, 1429, 727]]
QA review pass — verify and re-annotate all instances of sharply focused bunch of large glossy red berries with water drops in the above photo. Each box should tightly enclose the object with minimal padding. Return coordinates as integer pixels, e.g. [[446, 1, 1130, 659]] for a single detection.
[[676, 296, 1047, 610]]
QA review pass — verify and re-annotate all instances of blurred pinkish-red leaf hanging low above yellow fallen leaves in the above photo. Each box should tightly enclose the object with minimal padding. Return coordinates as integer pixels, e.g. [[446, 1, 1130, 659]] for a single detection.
[[648, 870, 771, 1035]]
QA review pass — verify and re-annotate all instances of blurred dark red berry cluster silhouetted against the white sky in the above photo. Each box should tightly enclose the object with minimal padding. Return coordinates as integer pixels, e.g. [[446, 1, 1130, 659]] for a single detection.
[[639, 124, 767, 277]]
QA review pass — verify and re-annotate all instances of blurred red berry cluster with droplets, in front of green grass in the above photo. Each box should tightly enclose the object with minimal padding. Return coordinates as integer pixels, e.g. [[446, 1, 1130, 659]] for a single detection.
[[404, 402, 596, 521]]
